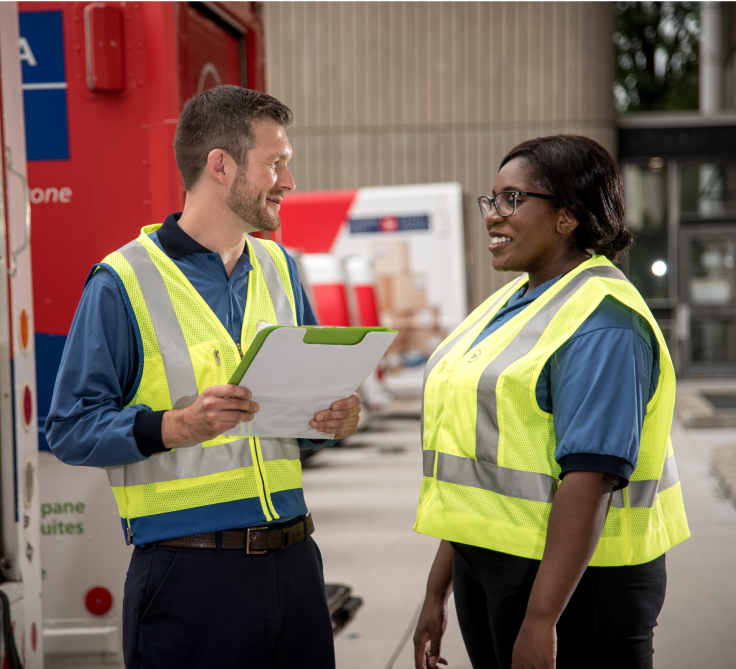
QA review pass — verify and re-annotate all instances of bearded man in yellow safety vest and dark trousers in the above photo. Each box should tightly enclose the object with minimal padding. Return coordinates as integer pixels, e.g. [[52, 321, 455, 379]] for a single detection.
[[46, 86, 360, 669]]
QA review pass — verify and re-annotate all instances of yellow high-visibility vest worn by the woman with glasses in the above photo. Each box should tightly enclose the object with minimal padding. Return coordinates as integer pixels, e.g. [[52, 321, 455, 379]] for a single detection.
[[414, 256, 690, 566]]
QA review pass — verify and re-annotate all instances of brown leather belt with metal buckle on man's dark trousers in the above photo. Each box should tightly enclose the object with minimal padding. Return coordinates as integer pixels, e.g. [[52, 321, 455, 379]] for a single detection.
[[158, 513, 314, 555]]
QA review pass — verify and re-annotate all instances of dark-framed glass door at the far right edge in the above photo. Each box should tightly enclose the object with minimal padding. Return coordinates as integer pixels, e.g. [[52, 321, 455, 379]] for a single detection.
[[680, 225, 736, 375]]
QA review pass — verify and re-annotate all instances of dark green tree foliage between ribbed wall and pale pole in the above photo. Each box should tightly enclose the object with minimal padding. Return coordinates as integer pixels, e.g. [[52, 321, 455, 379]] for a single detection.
[[613, 1, 700, 113]]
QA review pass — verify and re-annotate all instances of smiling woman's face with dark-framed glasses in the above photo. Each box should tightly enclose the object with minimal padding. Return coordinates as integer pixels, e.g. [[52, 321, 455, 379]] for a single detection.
[[486, 158, 577, 274]]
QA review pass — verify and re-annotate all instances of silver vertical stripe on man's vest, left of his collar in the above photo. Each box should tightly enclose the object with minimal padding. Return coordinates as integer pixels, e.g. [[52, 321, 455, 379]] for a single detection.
[[120, 241, 199, 409]]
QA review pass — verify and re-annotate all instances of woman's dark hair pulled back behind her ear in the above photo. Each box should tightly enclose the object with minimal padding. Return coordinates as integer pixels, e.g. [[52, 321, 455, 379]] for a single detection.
[[499, 135, 634, 260]]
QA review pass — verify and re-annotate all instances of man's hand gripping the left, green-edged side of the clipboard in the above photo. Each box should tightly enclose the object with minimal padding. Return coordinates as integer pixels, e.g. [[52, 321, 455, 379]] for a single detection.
[[161, 385, 258, 448]]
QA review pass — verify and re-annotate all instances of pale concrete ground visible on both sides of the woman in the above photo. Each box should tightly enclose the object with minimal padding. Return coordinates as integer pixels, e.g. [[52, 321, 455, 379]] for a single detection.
[[304, 392, 736, 669]]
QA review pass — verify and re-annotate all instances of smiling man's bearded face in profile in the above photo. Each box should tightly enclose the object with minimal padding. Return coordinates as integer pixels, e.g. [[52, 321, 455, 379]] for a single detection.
[[227, 120, 296, 231]]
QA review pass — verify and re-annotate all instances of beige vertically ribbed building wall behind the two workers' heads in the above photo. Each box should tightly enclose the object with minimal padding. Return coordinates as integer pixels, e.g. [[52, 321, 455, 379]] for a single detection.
[[264, 2, 616, 307]]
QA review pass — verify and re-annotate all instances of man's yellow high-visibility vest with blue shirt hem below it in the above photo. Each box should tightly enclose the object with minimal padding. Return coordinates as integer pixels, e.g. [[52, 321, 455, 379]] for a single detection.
[[100, 225, 306, 544]]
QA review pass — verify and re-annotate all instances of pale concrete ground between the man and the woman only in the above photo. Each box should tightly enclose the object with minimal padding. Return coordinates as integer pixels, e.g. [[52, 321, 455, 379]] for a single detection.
[[304, 419, 470, 669]]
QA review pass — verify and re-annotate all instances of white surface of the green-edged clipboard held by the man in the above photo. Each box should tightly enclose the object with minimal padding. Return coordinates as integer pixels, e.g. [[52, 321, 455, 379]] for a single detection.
[[225, 328, 396, 439]]
